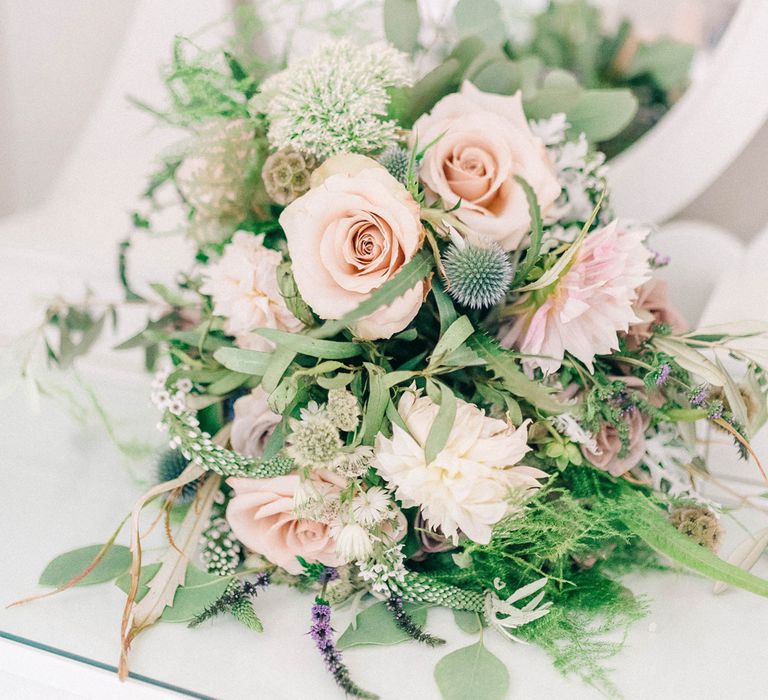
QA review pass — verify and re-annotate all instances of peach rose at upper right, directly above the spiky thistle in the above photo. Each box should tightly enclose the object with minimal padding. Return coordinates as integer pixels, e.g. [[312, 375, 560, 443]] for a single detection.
[[412, 82, 561, 250]]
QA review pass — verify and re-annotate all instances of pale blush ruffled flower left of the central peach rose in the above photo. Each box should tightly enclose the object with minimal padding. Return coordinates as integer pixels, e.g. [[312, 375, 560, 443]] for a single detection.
[[200, 231, 303, 350]]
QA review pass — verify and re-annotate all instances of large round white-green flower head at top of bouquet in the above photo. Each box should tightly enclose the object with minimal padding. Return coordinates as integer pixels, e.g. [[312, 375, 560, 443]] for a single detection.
[[254, 39, 412, 159]]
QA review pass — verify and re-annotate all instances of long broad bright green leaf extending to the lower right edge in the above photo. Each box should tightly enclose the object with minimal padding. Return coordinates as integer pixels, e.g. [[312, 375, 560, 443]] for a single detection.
[[621, 491, 768, 598]]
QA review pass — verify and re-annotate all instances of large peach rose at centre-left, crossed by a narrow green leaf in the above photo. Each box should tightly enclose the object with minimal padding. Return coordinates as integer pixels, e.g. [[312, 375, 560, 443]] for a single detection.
[[280, 155, 425, 340]]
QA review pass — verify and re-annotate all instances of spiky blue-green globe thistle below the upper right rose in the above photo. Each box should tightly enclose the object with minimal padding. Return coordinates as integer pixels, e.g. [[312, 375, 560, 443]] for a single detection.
[[443, 236, 514, 309]]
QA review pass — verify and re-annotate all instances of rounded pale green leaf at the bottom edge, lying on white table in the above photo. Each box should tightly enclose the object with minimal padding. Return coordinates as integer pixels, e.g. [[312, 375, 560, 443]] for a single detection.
[[435, 640, 509, 700]]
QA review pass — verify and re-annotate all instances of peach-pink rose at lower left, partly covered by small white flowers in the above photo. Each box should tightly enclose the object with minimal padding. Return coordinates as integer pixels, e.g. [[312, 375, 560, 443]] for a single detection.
[[222, 472, 342, 574]]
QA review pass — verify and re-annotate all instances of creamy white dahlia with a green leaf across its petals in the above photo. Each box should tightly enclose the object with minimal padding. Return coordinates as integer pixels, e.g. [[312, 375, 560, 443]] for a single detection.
[[375, 390, 547, 544]]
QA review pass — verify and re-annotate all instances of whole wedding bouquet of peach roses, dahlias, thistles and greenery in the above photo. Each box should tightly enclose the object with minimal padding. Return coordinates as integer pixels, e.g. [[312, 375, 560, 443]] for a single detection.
[[18, 3, 768, 698]]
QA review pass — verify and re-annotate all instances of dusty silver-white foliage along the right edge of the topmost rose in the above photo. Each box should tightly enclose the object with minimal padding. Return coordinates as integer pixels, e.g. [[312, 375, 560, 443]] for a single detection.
[[530, 114, 608, 249]]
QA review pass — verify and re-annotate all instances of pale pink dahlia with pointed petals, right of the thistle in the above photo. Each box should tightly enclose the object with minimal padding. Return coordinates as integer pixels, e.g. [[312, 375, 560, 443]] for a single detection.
[[501, 221, 650, 374]]
